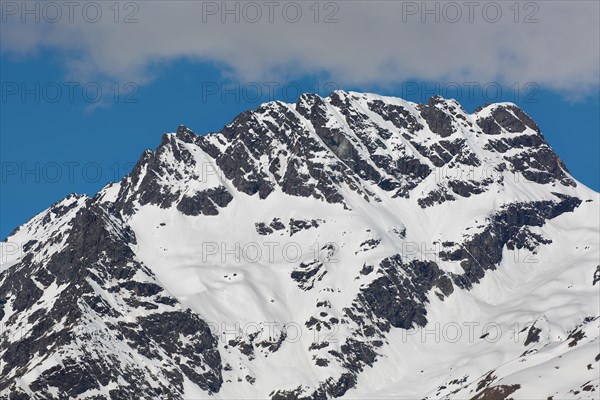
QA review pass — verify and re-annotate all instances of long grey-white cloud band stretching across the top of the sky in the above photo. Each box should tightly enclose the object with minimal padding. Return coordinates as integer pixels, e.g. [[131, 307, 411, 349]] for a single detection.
[[0, 1, 600, 96]]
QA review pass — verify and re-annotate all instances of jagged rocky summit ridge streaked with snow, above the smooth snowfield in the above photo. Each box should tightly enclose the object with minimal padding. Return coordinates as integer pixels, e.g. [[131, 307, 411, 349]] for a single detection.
[[106, 91, 576, 217]]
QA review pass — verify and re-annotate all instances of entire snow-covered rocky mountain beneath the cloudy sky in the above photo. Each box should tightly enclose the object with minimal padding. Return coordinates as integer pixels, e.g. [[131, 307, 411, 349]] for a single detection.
[[0, 91, 600, 400]]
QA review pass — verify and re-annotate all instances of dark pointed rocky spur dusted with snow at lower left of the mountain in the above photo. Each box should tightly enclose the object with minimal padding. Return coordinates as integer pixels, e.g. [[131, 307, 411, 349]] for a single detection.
[[0, 200, 222, 398]]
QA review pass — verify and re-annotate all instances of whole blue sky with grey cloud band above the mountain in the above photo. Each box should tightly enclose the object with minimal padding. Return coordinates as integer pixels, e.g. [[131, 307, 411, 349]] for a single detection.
[[0, 1, 600, 238]]
